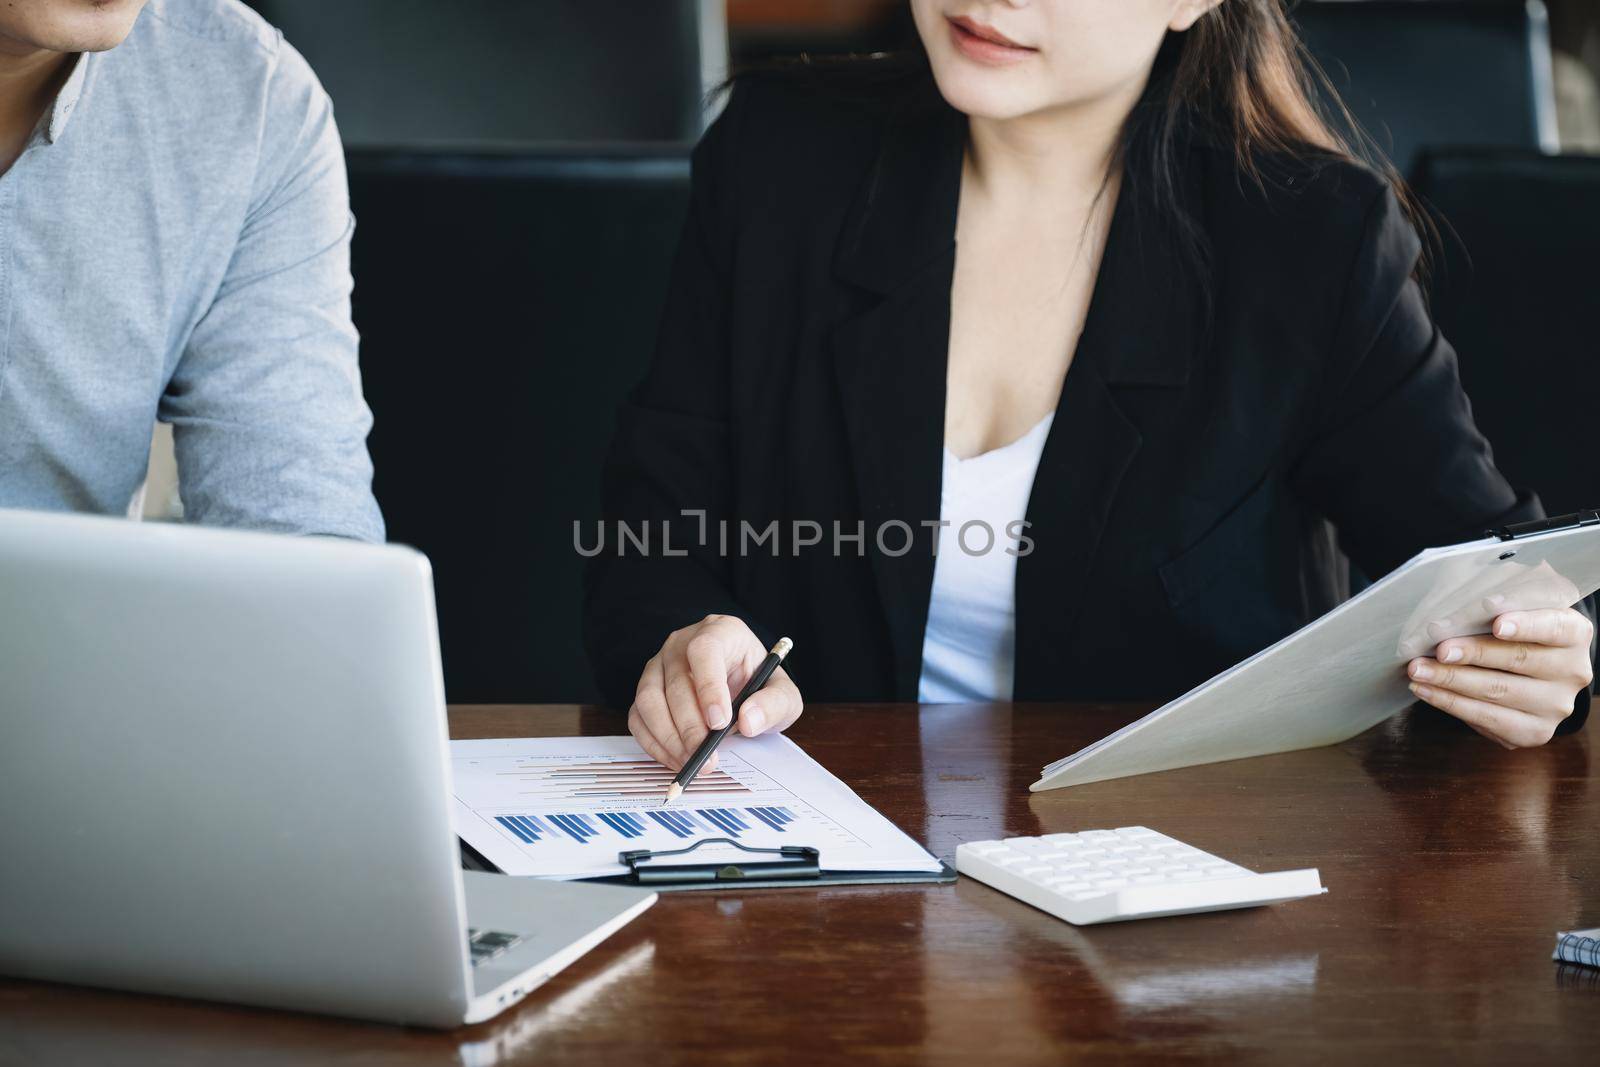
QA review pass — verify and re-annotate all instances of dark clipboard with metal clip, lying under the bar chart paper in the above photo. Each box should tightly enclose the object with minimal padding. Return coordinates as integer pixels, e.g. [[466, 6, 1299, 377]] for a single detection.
[[458, 837, 955, 893]]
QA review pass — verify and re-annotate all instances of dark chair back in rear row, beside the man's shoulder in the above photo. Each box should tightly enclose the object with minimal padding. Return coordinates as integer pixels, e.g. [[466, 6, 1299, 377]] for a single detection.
[[248, 0, 726, 152]]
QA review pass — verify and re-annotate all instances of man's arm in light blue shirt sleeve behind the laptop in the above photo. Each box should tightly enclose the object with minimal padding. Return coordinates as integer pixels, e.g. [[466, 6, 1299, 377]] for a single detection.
[[160, 42, 384, 541]]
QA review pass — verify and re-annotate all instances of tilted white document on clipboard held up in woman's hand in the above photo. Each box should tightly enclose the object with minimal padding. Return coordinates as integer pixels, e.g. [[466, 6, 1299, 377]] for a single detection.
[[1030, 525, 1600, 792]]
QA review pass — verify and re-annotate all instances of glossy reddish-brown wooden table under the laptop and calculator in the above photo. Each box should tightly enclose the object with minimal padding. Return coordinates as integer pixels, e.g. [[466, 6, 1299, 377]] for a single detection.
[[0, 705, 1600, 1067]]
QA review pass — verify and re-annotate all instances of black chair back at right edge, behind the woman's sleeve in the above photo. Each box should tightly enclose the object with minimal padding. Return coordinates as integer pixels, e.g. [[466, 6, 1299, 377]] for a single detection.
[[1416, 150, 1600, 515]]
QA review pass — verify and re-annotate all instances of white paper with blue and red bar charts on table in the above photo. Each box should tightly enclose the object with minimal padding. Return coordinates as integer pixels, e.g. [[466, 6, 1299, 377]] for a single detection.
[[450, 734, 939, 878]]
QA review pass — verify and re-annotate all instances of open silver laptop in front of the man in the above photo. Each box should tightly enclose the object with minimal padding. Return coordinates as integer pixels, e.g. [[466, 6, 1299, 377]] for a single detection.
[[0, 510, 656, 1027]]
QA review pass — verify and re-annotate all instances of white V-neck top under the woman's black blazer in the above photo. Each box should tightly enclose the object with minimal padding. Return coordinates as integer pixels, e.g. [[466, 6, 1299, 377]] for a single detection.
[[917, 413, 1056, 704]]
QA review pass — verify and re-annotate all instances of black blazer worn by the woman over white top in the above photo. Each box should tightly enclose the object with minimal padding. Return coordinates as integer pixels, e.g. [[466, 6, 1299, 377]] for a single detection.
[[584, 73, 1587, 726]]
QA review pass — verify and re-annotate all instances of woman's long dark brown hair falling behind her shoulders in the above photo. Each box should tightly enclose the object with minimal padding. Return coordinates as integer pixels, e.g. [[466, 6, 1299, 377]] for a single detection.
[[728, 0, 1437, 288]]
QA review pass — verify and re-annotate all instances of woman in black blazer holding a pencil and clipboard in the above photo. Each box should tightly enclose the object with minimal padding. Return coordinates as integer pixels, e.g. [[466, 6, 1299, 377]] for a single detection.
[[586, 0, 1594, 766]]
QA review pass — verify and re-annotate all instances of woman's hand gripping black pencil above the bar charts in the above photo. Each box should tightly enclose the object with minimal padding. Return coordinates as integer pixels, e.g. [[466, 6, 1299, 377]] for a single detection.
[[627, 614, 805, 771]]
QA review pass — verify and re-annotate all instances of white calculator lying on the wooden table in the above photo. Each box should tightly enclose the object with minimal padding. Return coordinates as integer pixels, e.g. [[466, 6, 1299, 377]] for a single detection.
[[955, 825, 1326, 926]]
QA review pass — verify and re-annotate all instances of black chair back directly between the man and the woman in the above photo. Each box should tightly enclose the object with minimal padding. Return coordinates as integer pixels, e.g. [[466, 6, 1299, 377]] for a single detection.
[[350, 150, 688, 702]]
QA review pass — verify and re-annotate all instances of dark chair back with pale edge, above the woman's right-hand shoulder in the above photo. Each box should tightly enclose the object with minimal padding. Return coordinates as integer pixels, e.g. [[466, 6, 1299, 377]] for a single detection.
[[1294, 0, 1558, 173]]
